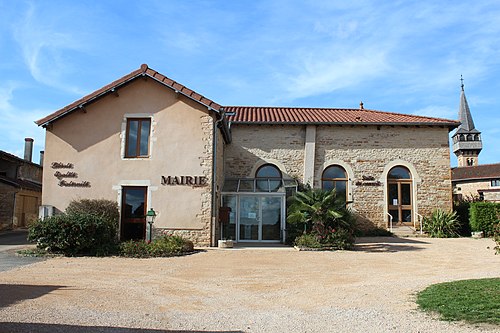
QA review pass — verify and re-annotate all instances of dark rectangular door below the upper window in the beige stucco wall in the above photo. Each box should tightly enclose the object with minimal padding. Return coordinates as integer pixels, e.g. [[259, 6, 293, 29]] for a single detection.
[[120, 186, 148, 240]]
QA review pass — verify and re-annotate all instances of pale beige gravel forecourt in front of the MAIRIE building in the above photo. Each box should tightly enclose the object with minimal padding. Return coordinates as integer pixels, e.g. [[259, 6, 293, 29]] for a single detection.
[[0, 238, 500, 333]]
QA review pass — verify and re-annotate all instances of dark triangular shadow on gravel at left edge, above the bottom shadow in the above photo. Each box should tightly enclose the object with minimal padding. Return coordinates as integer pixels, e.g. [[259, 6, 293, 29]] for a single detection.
[[0, 284, 65, 308]]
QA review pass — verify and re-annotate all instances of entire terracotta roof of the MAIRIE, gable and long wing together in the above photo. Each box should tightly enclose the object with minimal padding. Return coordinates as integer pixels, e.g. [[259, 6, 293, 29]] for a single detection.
[[35, 64, 460, 130]]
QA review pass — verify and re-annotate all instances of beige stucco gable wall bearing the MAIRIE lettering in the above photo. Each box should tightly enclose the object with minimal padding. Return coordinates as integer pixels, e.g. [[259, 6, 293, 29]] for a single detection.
[[42, 79, 213, 244]]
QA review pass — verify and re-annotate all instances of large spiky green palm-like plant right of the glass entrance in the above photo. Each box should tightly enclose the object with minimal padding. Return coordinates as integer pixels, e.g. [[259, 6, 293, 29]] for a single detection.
[[287, 189, 353, 233]]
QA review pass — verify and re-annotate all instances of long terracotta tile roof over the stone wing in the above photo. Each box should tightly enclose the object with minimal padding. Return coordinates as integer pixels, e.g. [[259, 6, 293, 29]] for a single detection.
[[224, 106, 460, 129]]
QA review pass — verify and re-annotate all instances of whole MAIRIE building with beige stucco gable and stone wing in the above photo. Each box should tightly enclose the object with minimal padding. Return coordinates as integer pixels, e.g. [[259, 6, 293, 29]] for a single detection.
[[33, 65, 460, 245]]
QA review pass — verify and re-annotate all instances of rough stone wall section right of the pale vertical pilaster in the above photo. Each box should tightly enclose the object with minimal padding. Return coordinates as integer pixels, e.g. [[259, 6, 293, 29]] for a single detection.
[[314, 126, 452, 227]]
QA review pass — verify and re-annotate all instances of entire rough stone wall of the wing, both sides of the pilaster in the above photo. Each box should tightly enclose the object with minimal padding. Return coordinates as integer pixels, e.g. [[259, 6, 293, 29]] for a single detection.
[[225, 124, 452, 228]]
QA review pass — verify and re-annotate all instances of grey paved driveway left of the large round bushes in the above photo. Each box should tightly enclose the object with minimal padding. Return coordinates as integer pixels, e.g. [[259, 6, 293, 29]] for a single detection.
[[0, 230, 43, 272]]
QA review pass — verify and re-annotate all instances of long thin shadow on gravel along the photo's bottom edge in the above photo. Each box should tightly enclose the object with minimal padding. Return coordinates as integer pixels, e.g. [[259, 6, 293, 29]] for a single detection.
[[0, 322, 243, 333]]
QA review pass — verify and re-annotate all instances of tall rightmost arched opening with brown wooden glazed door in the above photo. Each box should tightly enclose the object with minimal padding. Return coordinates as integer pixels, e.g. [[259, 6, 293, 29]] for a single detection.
[[387, 166, 413, 224]]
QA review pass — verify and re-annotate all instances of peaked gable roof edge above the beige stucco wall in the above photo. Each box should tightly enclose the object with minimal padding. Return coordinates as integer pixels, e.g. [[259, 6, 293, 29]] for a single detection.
[[35, 64, 221, 126]]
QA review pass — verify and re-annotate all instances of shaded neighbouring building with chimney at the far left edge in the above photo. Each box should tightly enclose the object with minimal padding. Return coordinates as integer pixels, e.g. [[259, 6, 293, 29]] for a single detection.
[[0, 138, 42, 230]]
